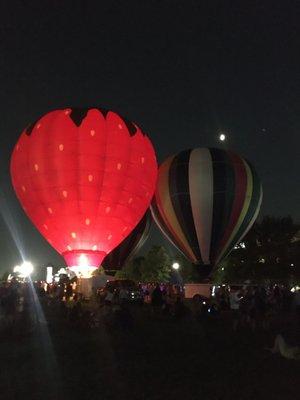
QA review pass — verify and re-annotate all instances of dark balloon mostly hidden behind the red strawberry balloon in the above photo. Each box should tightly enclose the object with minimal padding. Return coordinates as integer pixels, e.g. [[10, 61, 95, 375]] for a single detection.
[[101, 211, 152, 270]]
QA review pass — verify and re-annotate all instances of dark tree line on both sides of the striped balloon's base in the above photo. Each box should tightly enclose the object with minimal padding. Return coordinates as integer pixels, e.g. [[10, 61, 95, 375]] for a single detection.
[[116, 216, 300, 284]]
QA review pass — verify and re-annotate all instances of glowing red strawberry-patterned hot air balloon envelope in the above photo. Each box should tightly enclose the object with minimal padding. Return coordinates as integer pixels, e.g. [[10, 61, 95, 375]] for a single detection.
[[11, 108, 157, 266]]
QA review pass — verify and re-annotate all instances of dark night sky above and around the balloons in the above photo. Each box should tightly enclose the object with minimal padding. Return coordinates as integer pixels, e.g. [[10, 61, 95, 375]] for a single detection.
[[0, 0, 300, 272]]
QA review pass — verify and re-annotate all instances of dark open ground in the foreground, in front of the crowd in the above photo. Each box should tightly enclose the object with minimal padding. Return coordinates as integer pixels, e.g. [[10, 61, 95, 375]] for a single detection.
[[0, 307, 300, 400]]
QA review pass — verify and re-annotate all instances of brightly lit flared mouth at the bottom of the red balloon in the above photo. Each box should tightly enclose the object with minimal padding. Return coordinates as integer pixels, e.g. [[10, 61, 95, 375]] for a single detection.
[[62, 250, 106, 278]]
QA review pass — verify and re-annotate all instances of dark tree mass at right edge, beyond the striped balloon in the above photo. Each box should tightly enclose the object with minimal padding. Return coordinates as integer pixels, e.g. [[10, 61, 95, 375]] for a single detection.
[[213, 216, 300, 283]]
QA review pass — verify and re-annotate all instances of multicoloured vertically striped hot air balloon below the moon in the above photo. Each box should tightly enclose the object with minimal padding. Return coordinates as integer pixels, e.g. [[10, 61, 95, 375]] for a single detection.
[[151, 148, 262, 266]]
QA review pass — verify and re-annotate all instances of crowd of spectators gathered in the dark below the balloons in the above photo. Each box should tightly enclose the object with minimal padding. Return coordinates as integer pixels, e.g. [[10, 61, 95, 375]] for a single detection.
[[0, 278, 300, 340]]
